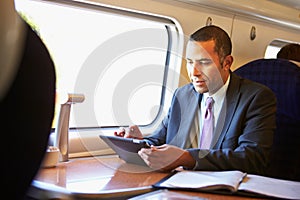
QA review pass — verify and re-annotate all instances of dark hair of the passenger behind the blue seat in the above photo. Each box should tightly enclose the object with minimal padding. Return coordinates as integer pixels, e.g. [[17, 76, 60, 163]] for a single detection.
[[277, 43, 300, 62]]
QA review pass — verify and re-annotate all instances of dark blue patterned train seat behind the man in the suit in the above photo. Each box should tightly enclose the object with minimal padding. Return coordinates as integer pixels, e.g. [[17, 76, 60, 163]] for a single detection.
[[234, 59, 300, 181]]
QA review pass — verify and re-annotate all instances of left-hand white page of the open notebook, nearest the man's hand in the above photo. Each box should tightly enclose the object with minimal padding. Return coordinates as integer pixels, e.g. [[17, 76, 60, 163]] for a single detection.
[[160, 170, 246, 192]]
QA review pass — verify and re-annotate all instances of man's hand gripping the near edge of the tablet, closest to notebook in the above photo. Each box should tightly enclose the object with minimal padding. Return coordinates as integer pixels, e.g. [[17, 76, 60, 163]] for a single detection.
[[138, 144, 196, 171]]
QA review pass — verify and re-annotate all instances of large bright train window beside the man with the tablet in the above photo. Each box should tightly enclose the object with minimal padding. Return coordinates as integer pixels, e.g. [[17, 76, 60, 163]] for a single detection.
[[16, 0, 183, 128]]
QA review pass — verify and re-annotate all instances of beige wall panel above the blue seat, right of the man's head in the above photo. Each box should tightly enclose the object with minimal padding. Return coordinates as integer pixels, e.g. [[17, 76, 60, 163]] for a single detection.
[[232, 16, 300, 70]]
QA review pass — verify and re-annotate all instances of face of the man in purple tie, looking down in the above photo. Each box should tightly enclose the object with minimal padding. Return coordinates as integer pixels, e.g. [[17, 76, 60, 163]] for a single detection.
[[186, 40, 231, 95]]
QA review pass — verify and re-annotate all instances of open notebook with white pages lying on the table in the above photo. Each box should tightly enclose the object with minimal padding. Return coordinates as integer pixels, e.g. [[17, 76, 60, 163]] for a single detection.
[[153, 170, 300, 199]]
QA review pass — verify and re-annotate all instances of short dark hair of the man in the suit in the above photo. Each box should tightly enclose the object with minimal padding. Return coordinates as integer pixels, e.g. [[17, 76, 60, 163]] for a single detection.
[[190, 25, 232, 63]]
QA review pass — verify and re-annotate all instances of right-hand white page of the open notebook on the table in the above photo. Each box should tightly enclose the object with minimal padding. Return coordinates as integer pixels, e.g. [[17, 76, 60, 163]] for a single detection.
[[239, 174, 300, 199]]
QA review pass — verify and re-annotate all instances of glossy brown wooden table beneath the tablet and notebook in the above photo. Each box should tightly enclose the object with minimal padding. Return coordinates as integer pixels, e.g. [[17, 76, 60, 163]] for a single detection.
[[28, 155, 268, 200]]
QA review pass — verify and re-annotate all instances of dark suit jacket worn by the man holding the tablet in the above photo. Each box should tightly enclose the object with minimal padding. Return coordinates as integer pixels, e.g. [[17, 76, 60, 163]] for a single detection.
[[145, 73, 276, 174]]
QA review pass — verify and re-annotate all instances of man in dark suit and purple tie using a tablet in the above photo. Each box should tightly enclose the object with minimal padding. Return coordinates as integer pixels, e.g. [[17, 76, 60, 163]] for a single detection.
[[116, 26, 276, 174]]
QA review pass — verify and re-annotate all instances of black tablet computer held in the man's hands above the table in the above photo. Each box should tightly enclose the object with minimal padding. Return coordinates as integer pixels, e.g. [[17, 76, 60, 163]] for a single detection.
[[99, 135, 150, 166]]
